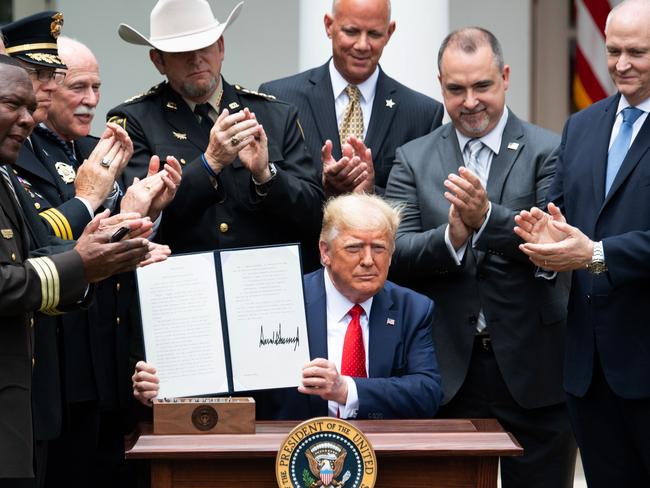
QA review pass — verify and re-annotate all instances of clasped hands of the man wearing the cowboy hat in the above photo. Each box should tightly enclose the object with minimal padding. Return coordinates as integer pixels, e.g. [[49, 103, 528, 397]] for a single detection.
[[204, 108, 271, 183]]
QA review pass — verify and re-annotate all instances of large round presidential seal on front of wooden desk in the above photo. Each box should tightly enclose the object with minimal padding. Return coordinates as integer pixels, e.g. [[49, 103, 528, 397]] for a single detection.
[[275, 417, 377, 488]]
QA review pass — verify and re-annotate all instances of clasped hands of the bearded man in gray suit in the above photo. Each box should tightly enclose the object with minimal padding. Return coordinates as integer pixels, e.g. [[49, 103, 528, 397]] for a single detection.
[[444, 166, 490, 250]]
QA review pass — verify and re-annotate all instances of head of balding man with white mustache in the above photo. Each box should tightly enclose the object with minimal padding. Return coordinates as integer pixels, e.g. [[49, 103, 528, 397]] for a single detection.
[[46, 36, 101, 141]]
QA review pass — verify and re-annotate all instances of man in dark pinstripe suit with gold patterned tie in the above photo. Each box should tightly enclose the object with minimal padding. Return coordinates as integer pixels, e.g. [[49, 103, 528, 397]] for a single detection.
[[260, 0, 444, 195]]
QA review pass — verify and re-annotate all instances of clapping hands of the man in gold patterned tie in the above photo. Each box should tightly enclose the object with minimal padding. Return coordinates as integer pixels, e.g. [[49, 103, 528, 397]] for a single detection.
[[321, 136, 375, 197]]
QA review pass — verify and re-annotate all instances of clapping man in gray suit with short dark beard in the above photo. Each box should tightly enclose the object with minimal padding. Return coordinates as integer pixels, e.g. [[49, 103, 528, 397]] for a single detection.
[[386, 28, 576, 488]]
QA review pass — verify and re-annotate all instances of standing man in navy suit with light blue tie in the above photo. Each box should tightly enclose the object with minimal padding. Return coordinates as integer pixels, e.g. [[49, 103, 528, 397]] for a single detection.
[[517, 1, 650, 487]]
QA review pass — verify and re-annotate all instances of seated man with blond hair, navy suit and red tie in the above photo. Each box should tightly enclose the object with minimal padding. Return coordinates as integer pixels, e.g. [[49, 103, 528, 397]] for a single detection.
[[133, 194, 442, 420]]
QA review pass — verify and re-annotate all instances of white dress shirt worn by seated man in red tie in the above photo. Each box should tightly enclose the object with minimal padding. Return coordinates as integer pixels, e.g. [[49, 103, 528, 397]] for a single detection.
[[323, 269, 372, 419]]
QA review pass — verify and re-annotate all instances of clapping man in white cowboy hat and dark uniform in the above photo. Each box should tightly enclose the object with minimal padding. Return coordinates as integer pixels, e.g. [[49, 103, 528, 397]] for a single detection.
[[108, 0, 323, 271]]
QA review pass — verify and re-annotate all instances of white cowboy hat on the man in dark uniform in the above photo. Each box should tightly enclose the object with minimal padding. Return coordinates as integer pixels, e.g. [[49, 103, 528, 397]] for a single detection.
[[117, 0, 244, 53]]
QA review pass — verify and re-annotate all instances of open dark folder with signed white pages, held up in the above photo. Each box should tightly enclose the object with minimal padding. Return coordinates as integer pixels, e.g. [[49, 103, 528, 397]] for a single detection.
[[137, 244, 309, 398]]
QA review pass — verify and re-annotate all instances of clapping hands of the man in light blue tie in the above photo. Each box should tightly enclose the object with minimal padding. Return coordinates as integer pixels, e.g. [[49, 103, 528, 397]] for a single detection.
[[514, 203, 594, 271]]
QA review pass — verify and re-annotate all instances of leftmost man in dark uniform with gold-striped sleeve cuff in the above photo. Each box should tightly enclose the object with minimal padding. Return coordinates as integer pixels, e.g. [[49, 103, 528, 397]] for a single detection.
[[0, 56, 148, 486]]
